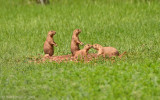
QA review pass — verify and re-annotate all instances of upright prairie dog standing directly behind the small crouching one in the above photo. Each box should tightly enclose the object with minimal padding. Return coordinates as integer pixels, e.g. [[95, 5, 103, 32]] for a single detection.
[[71, 29, 83, 56]]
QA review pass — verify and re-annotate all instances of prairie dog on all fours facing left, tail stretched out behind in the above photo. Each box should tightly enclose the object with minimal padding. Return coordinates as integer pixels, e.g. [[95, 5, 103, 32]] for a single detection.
[[93, 44, 126, 58]]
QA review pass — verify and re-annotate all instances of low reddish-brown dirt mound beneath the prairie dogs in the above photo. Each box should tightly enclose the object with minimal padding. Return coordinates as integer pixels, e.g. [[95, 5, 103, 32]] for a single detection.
[[28, 54, 126, 63]]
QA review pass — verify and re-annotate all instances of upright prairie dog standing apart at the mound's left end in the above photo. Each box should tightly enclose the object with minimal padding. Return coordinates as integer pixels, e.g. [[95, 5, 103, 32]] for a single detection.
[[43, 31, 57, 56]]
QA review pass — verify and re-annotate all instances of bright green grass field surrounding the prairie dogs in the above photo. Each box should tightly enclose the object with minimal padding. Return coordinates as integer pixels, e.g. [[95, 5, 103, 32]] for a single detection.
[[0, 0, 160, 100]]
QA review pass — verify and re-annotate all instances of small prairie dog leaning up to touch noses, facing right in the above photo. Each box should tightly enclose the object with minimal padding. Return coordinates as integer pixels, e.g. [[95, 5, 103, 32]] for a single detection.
[[74, 44, 93, 58]]
